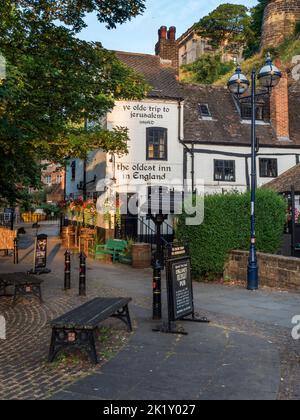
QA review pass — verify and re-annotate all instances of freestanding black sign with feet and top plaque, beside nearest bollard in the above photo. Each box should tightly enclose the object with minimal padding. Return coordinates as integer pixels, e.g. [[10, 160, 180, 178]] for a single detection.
[[154, 244, 209, 335]]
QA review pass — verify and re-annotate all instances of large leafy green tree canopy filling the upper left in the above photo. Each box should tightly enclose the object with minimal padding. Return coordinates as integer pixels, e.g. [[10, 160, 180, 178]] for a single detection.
[[0, 0, 147, 203]]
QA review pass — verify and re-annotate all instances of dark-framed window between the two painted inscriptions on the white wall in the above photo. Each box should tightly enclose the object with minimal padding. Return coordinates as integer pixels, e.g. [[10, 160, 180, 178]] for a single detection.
[[146, 127, 168, 160]]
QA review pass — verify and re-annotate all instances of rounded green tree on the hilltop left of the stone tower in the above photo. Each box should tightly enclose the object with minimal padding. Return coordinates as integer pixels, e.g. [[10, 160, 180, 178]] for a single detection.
[[196, 3, 251, 48]]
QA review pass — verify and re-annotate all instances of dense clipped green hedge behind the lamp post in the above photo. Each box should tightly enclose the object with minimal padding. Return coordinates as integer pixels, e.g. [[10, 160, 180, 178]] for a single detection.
[[176, 189, 286, 278]]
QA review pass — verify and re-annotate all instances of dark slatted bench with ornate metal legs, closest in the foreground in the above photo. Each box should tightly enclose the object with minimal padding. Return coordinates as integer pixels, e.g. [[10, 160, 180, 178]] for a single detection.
[[49, 298, 132, 364]]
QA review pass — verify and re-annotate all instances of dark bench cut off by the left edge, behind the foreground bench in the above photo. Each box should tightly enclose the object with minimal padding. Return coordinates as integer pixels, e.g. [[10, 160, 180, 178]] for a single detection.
[[0, 273, 43, 304]]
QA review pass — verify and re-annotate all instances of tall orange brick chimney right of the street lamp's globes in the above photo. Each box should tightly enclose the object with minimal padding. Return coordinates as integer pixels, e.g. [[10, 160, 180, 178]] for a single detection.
[[270, 61, 290, 141]]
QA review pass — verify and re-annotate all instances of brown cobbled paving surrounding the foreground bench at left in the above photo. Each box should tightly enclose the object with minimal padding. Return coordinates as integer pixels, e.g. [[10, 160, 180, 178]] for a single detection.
[[0, 226, 135, 400]]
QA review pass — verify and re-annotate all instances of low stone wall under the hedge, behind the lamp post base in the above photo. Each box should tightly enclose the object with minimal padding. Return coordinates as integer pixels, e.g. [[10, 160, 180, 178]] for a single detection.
[[224, 251, 300, 289]]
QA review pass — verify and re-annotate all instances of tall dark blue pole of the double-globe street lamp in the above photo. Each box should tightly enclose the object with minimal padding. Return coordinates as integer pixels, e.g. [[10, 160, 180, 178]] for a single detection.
[[247, 69, 259, 290]]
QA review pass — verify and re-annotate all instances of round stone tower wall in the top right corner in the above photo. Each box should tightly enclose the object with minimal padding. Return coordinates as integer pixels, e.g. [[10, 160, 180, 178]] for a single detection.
[[261, 0, 300, 49]]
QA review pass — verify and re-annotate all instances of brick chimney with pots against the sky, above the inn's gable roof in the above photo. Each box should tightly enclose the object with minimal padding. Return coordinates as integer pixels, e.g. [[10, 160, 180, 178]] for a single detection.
[[155, 26, 179, 70]]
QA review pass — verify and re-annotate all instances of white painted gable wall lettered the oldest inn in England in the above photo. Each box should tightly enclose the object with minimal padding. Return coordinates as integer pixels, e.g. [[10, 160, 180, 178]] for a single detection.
[[107, 100, 183, 198]]
